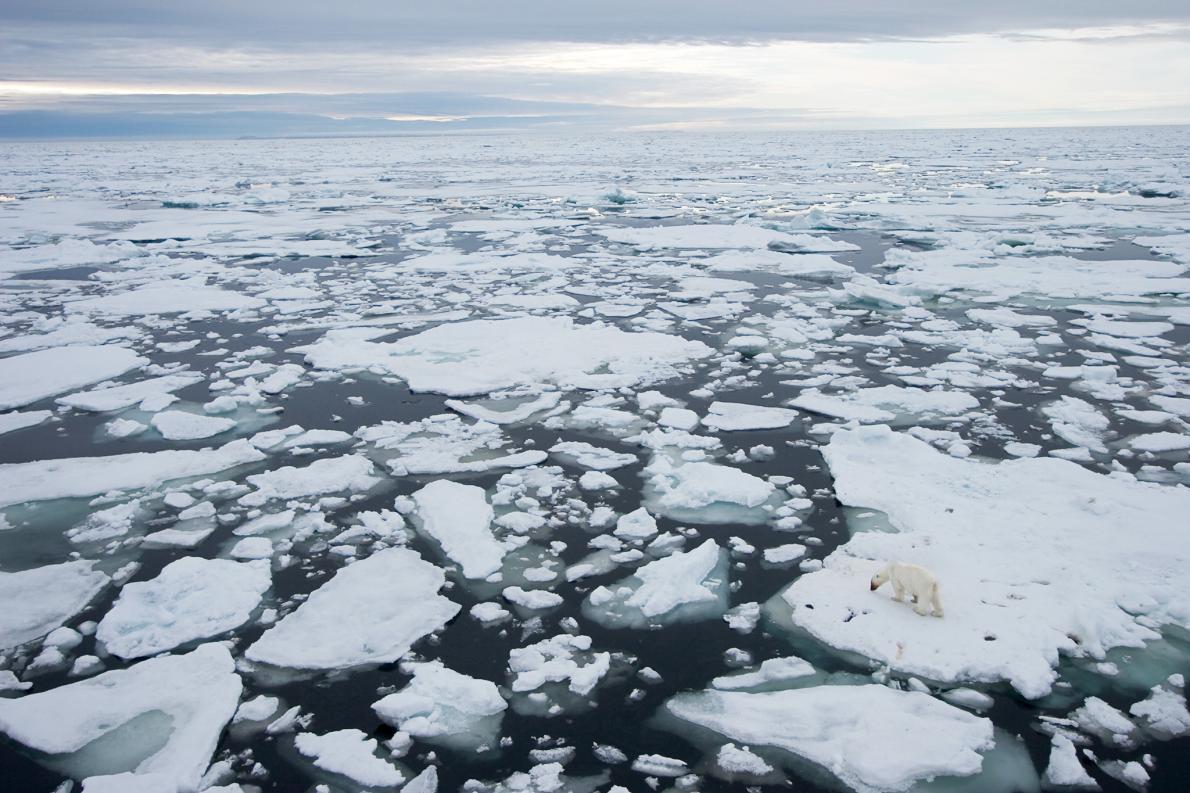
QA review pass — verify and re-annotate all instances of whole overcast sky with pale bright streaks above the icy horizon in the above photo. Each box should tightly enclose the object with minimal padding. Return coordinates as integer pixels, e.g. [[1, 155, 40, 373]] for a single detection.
[[0, 0, 1190, 138]]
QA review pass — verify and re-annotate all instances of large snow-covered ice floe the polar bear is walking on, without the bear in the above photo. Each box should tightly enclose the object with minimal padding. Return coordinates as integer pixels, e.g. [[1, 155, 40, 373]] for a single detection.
[[781, 425, 1190, 698]]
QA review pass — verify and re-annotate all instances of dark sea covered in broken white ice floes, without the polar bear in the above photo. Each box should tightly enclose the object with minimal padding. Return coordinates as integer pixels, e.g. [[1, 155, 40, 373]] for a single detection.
[[0, 127, 1190, 793]]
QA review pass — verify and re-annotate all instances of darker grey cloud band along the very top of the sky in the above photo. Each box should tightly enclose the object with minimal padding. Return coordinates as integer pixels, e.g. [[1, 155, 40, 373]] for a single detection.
[[0, 0, 1190, 46]]
